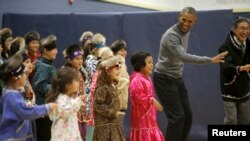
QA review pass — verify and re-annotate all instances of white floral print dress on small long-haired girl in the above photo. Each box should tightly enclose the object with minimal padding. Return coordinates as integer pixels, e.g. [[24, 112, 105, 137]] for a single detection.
[[49, 94, 84, 141]]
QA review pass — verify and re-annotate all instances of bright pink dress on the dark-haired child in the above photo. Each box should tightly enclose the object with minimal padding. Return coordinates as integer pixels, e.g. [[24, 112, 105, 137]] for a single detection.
[[129, 72, 165, 141]]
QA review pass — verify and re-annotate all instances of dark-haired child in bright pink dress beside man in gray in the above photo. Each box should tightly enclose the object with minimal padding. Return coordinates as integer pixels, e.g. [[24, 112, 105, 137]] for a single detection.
[[129, 52, 164, 141]]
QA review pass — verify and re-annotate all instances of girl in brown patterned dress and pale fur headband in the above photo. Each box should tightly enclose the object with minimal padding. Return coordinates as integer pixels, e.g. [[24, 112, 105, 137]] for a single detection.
[[93, 56, 126, 141]]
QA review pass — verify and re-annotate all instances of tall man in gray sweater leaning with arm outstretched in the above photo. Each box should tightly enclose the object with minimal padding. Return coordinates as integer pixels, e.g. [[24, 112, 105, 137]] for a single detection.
[[153, 7, 227, 141]]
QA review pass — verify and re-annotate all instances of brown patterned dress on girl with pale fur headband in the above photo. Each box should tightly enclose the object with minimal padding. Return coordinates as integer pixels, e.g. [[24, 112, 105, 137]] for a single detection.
[[93, 85, 126, 141]]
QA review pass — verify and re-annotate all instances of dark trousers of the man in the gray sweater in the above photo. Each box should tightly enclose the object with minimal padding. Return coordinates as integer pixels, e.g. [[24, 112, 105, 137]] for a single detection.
[[153, 72, 192, 141]]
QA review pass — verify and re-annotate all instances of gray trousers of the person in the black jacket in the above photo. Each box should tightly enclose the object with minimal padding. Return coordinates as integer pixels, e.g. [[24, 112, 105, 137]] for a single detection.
[[223, 99, 250, 125]]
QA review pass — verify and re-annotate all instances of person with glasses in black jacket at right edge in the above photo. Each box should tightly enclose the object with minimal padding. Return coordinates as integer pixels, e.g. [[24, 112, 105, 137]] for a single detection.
[[219, 17, 250, 125]]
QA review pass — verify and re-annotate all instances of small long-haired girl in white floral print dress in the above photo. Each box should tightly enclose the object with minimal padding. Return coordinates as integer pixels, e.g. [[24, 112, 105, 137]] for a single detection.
[[46, 67, 86, 141]]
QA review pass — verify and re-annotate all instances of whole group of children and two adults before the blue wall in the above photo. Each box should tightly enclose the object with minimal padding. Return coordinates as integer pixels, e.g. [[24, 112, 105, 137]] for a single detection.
[[0, 7, 250, 141]]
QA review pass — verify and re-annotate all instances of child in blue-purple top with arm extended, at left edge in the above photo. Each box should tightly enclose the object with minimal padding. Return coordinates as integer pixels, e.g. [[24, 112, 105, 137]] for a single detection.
[[0, 55, 57, 141]]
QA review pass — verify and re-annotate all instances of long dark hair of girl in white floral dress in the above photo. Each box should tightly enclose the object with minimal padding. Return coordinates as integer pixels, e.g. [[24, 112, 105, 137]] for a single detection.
[[46, 67, 78, 103]]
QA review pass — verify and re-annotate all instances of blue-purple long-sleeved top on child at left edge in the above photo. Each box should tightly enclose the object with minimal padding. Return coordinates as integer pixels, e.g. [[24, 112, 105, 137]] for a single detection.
[[0, 89, 49, 141]]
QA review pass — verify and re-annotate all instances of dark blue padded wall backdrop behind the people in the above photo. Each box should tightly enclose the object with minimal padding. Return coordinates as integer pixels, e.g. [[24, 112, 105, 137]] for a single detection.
[[3, 10, 235, 141]]
